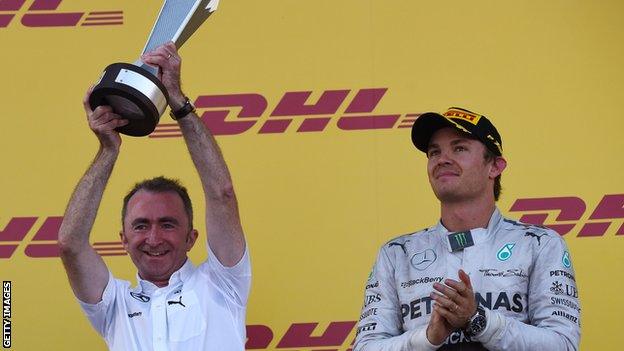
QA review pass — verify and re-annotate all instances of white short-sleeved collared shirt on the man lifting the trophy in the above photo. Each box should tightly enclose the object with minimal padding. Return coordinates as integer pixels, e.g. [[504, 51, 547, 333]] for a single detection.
[[79, 248, 251, 351]]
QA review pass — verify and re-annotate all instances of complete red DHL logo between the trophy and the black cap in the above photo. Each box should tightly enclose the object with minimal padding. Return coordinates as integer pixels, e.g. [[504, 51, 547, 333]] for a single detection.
[[149, 88, 420, 138]]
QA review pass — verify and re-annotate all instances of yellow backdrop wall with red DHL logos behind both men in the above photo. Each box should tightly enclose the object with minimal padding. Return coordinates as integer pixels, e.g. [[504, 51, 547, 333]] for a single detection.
[[0, 0, 624, 350]]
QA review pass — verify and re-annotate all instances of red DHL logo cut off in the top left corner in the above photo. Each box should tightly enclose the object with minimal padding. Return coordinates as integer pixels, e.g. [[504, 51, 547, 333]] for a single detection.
[[0, 0, 123, 28]]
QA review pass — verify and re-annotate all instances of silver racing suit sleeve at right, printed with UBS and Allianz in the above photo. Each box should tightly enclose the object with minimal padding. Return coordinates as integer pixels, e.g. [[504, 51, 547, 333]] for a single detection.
[[478, 230, 581, 351]]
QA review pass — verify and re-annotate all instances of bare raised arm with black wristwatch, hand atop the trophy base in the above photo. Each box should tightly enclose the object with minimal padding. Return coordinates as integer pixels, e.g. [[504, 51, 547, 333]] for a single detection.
[[142, 42, 245, 267]]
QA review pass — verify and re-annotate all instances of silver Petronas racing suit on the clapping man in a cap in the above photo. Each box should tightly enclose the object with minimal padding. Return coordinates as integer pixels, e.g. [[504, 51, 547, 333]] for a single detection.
[[353, 209, 580, 351]]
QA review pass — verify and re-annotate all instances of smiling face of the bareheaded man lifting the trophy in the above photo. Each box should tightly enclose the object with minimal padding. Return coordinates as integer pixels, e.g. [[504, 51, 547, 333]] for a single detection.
[[121, 190, 197, 282]]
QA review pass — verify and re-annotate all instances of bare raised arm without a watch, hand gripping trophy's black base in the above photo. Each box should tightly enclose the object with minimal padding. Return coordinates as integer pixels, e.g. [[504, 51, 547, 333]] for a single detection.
[[58, 91, 127, 303]]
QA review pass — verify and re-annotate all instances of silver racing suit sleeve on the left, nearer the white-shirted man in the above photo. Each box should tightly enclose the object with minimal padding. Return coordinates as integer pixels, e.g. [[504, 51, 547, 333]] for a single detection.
[[353, 246, 437, 351]]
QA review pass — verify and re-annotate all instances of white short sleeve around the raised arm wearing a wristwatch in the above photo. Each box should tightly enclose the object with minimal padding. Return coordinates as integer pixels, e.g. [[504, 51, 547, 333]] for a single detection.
[[201, 245, 251, 307]]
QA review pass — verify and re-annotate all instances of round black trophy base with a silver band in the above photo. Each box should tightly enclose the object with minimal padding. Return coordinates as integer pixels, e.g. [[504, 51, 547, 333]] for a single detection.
[[89, 63, 168, 136]]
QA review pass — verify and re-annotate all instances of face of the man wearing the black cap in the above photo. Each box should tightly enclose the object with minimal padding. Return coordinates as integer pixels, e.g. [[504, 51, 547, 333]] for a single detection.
[[427, 127, 504, 203]]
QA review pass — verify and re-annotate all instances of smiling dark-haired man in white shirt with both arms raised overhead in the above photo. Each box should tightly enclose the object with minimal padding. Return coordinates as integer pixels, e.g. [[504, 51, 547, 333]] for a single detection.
[[59, 42, 251, 351]]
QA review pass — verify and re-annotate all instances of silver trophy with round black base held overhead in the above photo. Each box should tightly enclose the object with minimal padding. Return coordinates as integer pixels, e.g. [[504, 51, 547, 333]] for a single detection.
[[89, 0, 219, 136]]
